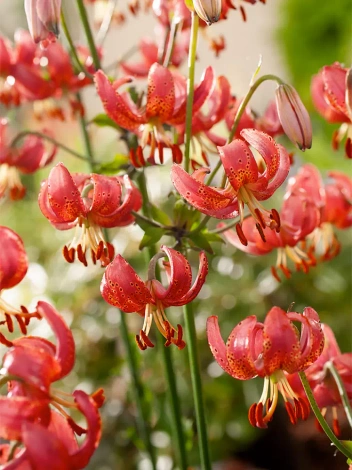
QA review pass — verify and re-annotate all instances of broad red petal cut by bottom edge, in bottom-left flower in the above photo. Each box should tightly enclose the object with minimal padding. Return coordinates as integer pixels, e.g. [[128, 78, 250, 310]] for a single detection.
[[22, 423, 73, 470]]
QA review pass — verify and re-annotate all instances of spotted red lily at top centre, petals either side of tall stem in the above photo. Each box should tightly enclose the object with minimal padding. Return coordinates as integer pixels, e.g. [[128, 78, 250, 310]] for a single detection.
[[95, 63, 214, 166]]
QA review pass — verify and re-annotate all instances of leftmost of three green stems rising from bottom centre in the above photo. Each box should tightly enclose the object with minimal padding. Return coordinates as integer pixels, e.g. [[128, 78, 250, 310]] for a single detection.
[[120, 312, 156, 470]]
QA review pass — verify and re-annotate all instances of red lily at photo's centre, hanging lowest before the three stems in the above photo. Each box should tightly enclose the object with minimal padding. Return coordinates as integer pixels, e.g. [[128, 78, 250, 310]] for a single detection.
[[100, 245, 208, 350]]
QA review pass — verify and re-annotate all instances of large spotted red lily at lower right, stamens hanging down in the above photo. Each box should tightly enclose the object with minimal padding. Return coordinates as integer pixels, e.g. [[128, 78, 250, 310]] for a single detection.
[[207, 307, 324, 428]]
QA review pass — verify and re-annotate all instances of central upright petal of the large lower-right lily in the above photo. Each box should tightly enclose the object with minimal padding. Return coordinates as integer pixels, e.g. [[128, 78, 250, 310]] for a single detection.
[[263, 307, 301, 376]]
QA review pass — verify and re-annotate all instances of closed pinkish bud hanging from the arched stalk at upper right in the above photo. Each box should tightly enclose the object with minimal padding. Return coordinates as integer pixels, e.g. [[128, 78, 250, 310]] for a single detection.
[[276, 83, 312, 150]]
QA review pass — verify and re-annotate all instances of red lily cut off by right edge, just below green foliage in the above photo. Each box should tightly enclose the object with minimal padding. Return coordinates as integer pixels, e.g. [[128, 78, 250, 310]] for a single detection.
[[311, 62, 352, 158]]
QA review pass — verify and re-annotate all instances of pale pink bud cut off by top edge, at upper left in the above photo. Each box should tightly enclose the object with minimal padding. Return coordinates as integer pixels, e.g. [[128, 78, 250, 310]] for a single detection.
[[24, 0, 61, 43]]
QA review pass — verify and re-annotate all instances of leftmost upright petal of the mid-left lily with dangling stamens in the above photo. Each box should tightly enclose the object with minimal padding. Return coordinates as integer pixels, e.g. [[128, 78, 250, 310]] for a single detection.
[[44, 163, 87, 223]]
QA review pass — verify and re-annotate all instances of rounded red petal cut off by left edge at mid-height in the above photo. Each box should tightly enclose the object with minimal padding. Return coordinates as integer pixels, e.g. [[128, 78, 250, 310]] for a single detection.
[[0, 226, 28, 291]]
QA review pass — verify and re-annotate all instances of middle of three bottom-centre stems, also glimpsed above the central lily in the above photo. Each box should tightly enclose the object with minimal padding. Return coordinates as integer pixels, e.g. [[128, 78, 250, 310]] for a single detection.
[[137, 170, 188, 470]]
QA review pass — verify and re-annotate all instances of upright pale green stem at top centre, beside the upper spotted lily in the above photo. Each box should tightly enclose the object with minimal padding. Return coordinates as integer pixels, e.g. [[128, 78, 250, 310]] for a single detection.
[[185, 11, 199, 172]]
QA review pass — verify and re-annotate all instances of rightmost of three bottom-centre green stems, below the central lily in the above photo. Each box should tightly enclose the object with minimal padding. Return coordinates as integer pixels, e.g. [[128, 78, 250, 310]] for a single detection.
[[183, 304, 211, 470]]
